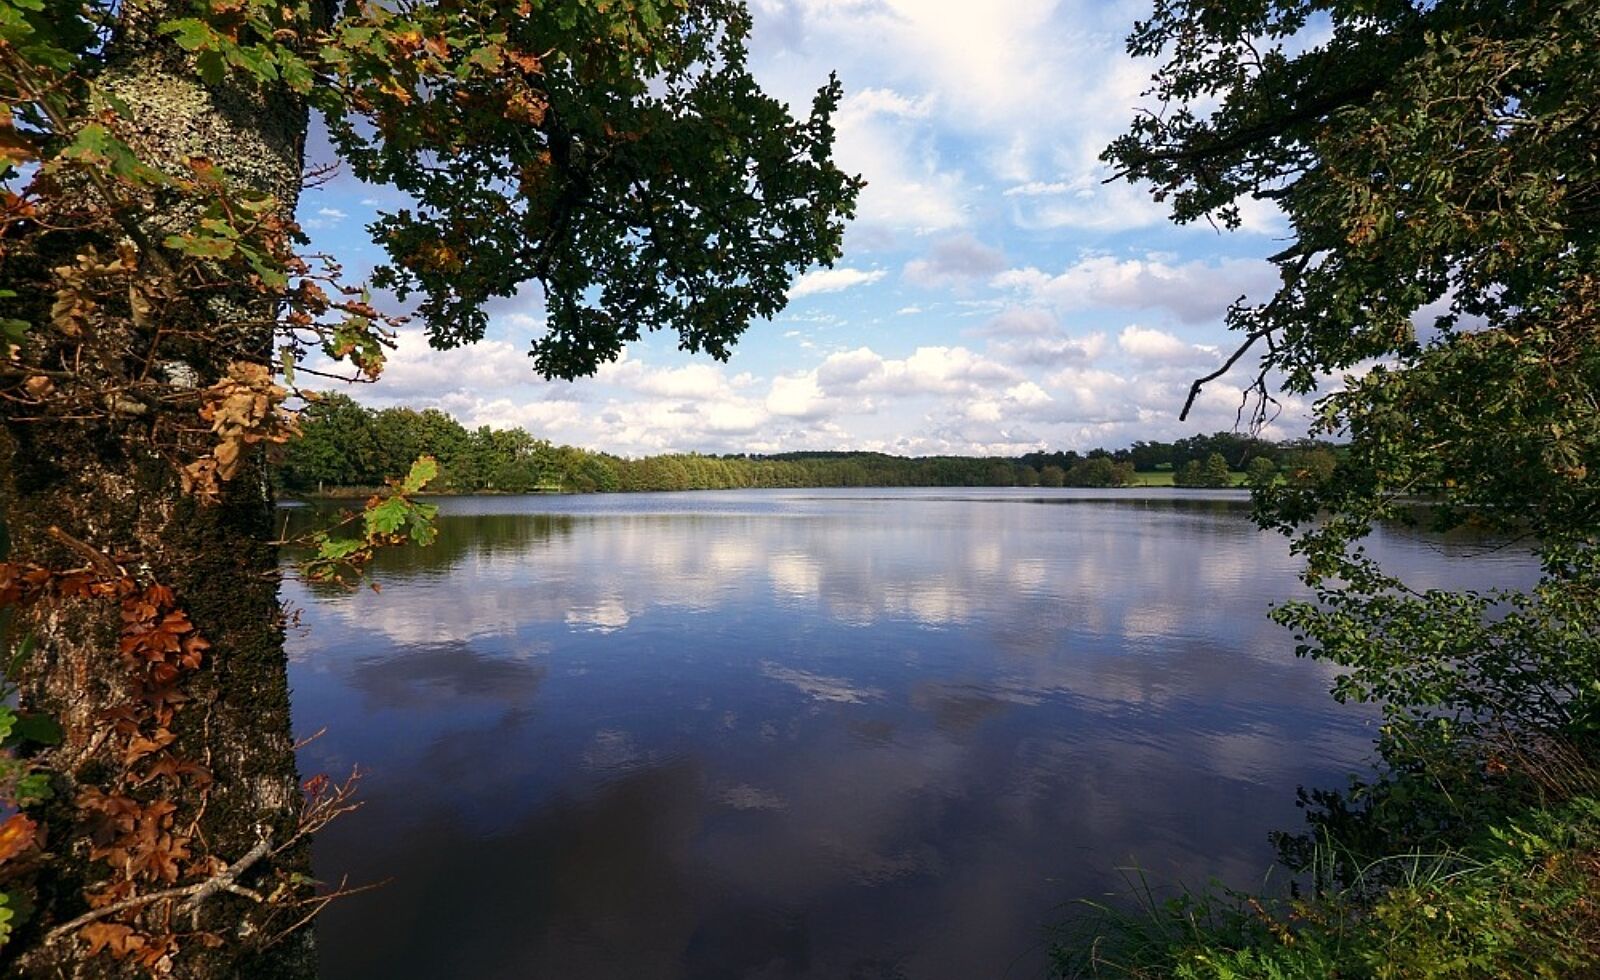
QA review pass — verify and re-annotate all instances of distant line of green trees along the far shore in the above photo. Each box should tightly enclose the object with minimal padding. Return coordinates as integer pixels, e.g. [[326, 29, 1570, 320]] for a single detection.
[[277, 394, 1338, 493]]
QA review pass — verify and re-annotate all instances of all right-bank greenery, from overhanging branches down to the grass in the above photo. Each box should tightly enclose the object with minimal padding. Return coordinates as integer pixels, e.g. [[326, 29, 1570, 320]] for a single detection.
[[1058, 0, 1600, 978]]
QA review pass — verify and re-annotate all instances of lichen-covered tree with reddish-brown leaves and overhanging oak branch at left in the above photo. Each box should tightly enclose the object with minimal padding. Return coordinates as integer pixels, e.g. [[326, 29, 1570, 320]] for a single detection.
[[0, 0, 859, 977]]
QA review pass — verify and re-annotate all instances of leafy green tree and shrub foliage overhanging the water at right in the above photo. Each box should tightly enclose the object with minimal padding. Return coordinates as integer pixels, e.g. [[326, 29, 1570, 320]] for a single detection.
[[1106, 0, 1600, 850]]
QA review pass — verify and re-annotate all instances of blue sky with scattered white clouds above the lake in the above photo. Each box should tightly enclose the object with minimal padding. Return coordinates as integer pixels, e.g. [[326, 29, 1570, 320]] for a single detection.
[[299, 0, 1306, 456]]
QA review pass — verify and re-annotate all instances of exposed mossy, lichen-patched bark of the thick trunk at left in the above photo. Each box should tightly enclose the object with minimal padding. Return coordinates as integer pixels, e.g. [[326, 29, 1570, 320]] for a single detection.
[[0, 0, 328, 978]]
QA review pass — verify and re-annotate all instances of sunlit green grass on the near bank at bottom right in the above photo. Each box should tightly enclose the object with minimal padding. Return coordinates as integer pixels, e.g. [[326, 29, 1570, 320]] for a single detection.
[[1054, 796, 1600, 980]]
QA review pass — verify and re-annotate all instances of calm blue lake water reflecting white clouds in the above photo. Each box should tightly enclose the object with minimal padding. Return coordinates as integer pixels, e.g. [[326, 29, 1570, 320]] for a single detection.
[[285, 490, 1528, 980]]
